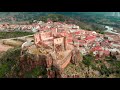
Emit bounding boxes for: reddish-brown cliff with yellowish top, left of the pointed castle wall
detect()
[20,46,71,78]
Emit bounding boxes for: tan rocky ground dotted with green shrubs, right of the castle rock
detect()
[62,58,120,78]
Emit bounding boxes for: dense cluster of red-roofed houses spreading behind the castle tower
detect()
[34,21,120,57]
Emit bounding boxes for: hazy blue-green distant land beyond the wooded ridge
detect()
[0,12,120,29]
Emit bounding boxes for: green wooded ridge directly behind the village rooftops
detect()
[30,14,103,32]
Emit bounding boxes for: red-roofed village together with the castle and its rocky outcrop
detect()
[15,20,120,78]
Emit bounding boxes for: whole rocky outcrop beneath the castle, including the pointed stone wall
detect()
[20,42,85,78]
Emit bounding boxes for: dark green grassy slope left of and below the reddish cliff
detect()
[0,47,45,78]
